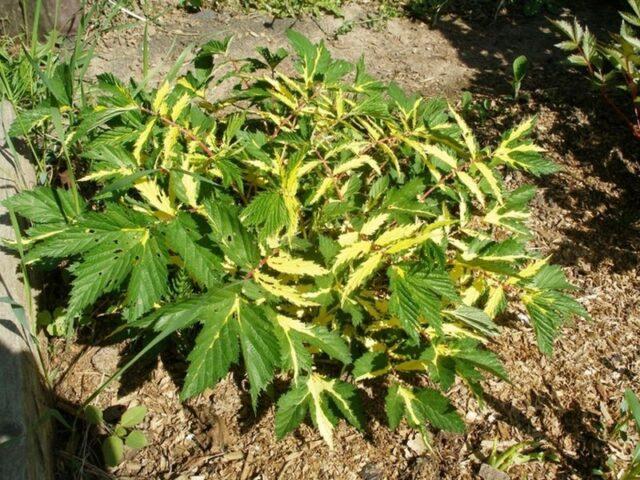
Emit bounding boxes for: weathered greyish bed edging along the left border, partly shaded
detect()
[0,102,52,480]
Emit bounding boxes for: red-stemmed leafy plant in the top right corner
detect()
[553,0,640,139]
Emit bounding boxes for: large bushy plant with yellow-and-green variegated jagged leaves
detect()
[6,31,586,445]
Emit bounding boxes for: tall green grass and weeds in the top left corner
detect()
[0,0,146,187]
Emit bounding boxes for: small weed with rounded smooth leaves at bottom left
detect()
[84,405,148,467]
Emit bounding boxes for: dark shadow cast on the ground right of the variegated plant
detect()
[412,1,640,272]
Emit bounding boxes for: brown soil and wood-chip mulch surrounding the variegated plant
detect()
[50,2,640,480]
